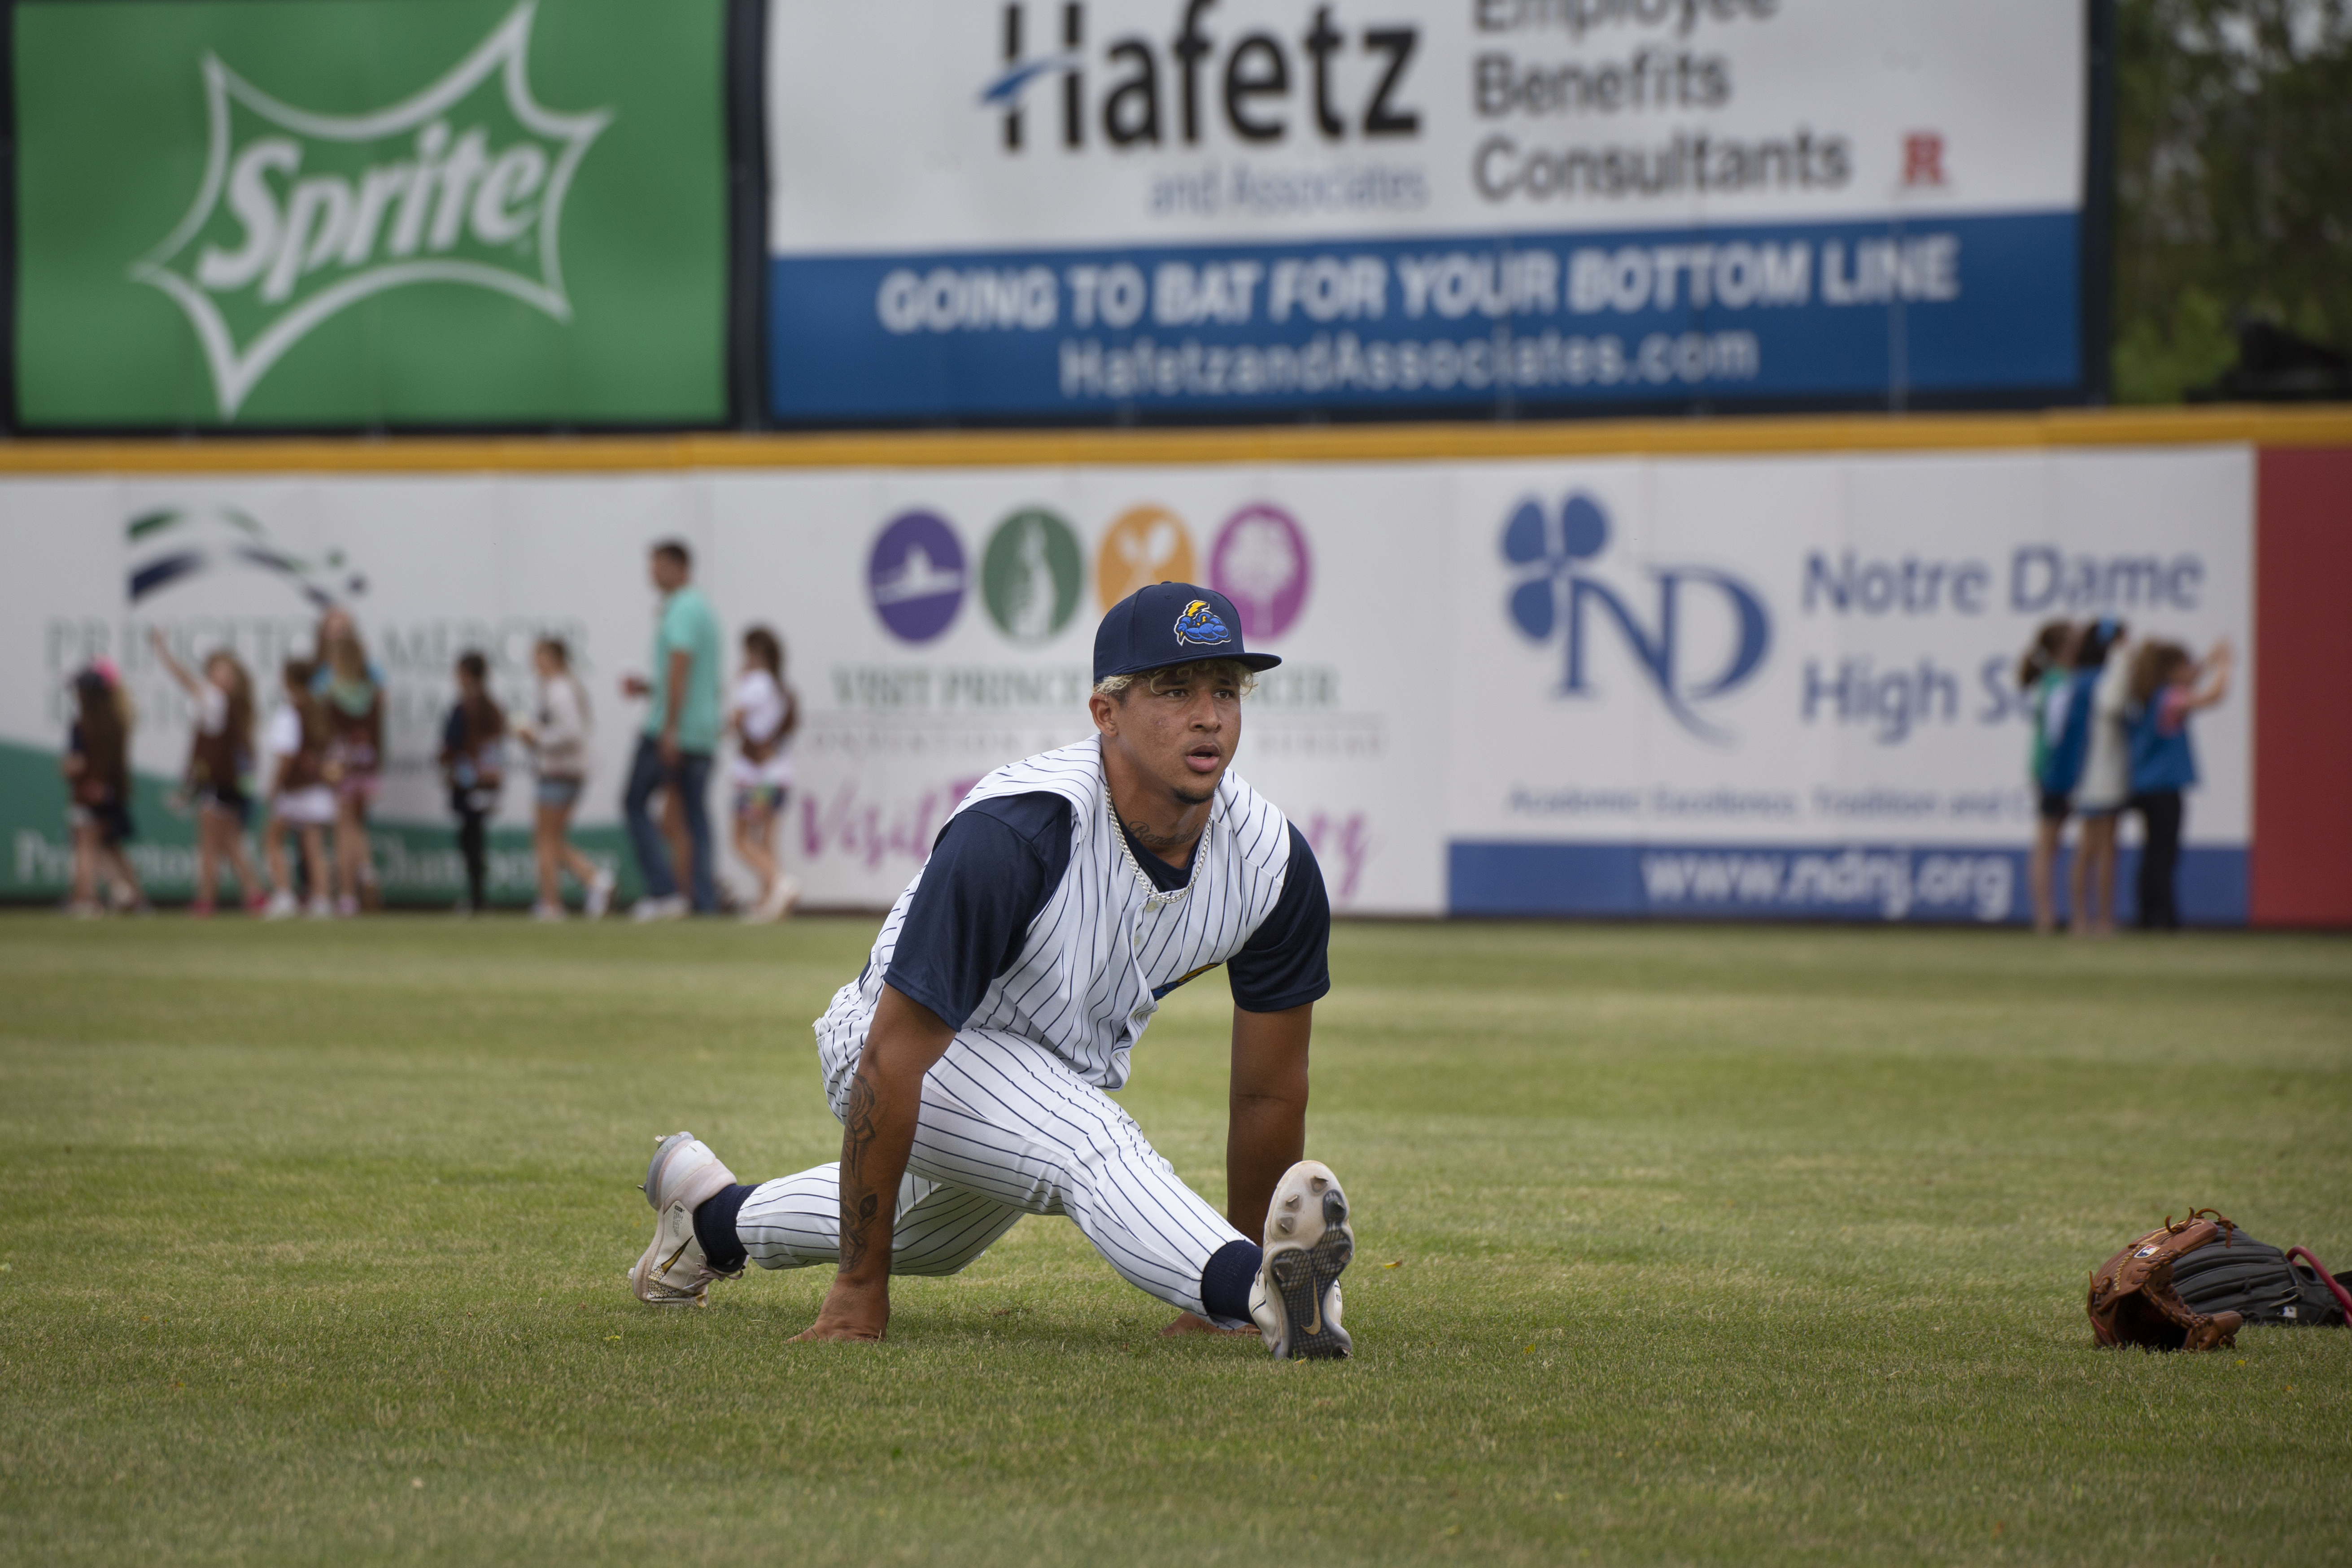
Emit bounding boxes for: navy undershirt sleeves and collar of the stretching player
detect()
[884,792,1331,1030]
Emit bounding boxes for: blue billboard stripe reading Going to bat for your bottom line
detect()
[769,212,2081,421]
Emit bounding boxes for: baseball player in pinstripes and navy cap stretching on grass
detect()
[630,583,1355,1359]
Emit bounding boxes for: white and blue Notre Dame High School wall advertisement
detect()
[1446,449,2256,922]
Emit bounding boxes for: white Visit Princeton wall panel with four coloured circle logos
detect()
[706,468,1446,912]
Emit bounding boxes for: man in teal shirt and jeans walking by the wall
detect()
[621,538,722,919]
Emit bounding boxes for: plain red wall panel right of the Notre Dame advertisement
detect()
[2248,447,2352,926]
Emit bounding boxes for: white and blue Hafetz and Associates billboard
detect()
[767,0,2086,421]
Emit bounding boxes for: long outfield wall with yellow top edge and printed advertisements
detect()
[0,414,2352,924]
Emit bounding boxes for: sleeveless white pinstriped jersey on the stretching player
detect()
[816,738,1291,1098]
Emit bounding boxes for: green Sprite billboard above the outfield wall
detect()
[12,0,727,428]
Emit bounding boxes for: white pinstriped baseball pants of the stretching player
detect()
[736,1030,1244,1312]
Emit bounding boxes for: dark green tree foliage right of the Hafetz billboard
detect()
[2114,0,2352,402]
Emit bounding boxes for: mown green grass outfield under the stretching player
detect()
[0,915,2352,1568]
